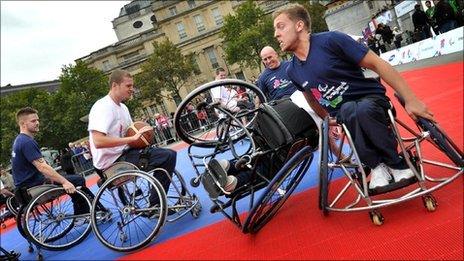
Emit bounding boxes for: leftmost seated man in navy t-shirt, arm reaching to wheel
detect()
[11,107,104,214]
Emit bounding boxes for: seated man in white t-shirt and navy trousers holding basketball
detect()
[88,70,177,204]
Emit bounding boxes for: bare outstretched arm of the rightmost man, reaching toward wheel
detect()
[359,50,435,121]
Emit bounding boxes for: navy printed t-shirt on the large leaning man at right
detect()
[287,31,385,116]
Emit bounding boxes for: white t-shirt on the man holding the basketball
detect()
[88,95,132,170]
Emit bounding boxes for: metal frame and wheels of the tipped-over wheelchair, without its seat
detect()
[174,79,313,233]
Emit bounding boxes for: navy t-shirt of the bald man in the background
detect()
[256,61,296,100]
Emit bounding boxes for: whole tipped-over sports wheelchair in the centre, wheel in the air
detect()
[174,79,319,233]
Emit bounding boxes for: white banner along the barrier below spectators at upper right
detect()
[380,27,464,65]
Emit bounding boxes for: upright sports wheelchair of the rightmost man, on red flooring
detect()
[319,94,464,223]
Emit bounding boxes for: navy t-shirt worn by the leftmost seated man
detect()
[11,133,45,187]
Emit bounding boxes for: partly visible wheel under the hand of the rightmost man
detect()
[418,118,464,167]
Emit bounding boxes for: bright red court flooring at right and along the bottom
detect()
[120,62,464,260]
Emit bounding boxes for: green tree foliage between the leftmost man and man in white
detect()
[0,62,109,164]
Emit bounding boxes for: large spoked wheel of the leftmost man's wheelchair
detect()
[24,187,91,250]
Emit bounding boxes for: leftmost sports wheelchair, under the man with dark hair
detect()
[10,184,92,260]
